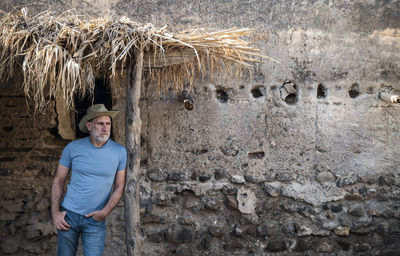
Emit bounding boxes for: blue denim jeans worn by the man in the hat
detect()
[57,209,106,256]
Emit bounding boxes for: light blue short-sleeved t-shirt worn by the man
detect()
[60,137,126,215]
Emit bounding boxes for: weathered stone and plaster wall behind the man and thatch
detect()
[0,0,400,255]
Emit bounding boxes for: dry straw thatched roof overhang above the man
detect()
[0,9,276,110]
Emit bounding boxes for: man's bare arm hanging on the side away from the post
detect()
[51,163,71,230]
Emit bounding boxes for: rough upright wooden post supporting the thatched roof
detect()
[125,49,143,256]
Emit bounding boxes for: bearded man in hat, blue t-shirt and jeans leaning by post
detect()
[51,104,126,256]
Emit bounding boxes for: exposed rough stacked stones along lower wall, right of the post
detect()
[141,165,400,255]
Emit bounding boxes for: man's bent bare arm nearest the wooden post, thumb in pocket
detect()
[85,169,125,221]
